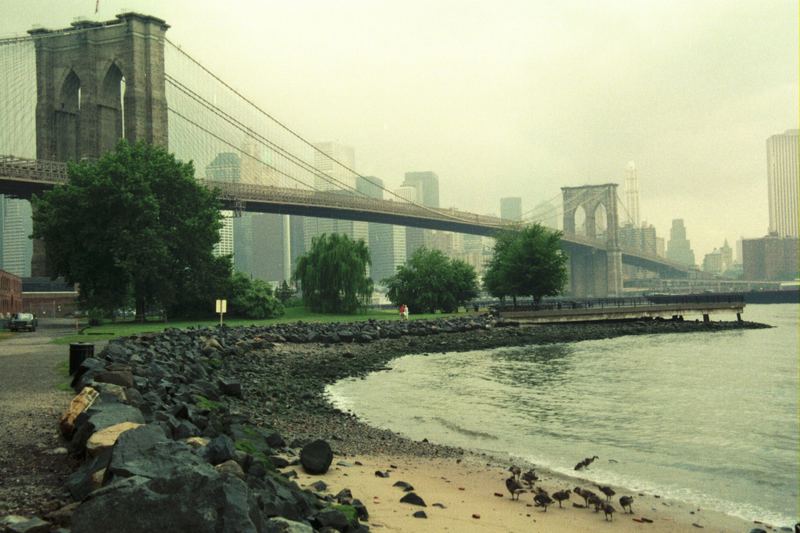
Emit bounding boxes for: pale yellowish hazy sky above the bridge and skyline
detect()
[0,0,800,263]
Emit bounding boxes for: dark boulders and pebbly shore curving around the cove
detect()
[7,315,768,533]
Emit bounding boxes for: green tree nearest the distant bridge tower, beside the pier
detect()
[483,224,567,302]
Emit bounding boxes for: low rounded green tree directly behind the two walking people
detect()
[383,248,478,313]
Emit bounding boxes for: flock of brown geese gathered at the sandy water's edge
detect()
[506,456,633,520]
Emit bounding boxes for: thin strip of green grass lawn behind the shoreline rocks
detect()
[53,307,463,344]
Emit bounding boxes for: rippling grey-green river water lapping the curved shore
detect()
[328,304,800,525]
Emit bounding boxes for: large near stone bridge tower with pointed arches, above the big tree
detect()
[28,13,169,161]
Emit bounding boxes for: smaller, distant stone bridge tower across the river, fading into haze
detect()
[561,183,622,297]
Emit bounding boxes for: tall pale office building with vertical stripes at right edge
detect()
[767,130,800,237]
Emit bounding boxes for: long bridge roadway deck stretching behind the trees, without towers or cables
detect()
[0,155,687,277]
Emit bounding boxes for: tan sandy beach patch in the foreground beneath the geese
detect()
[296,455,764,533]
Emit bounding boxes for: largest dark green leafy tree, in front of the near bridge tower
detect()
[33,141,225,320]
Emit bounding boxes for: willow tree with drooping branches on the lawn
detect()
[292,233,372,313]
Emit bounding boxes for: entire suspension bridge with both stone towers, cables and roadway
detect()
[0,13,688,297]
